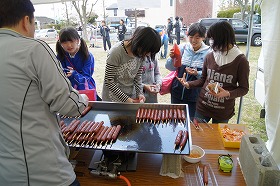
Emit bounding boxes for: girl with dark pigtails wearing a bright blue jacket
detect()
[56,27,98,100]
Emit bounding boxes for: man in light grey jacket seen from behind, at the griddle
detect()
[0,0,88,186]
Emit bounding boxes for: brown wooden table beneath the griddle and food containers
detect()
[72,124,246,186]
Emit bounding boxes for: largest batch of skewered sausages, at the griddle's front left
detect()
[60,119,121,148]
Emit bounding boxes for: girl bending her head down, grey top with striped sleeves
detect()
[102,27,161,103]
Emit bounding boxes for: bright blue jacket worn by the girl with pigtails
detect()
[59,51,96,90]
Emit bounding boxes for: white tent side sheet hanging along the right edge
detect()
[261,0,280,168]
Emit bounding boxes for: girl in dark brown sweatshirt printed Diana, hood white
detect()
[178,21,250,123]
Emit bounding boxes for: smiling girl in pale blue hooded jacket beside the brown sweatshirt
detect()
[165,23,210,120]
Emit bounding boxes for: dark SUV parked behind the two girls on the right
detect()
[198,18,262,46]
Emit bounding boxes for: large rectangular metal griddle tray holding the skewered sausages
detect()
[63,101,191,155]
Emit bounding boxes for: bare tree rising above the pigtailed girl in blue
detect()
[72,0,98,41]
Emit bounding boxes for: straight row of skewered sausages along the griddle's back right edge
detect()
[136,108,186,124]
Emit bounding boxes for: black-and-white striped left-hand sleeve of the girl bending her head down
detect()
[104,63,129,102]
